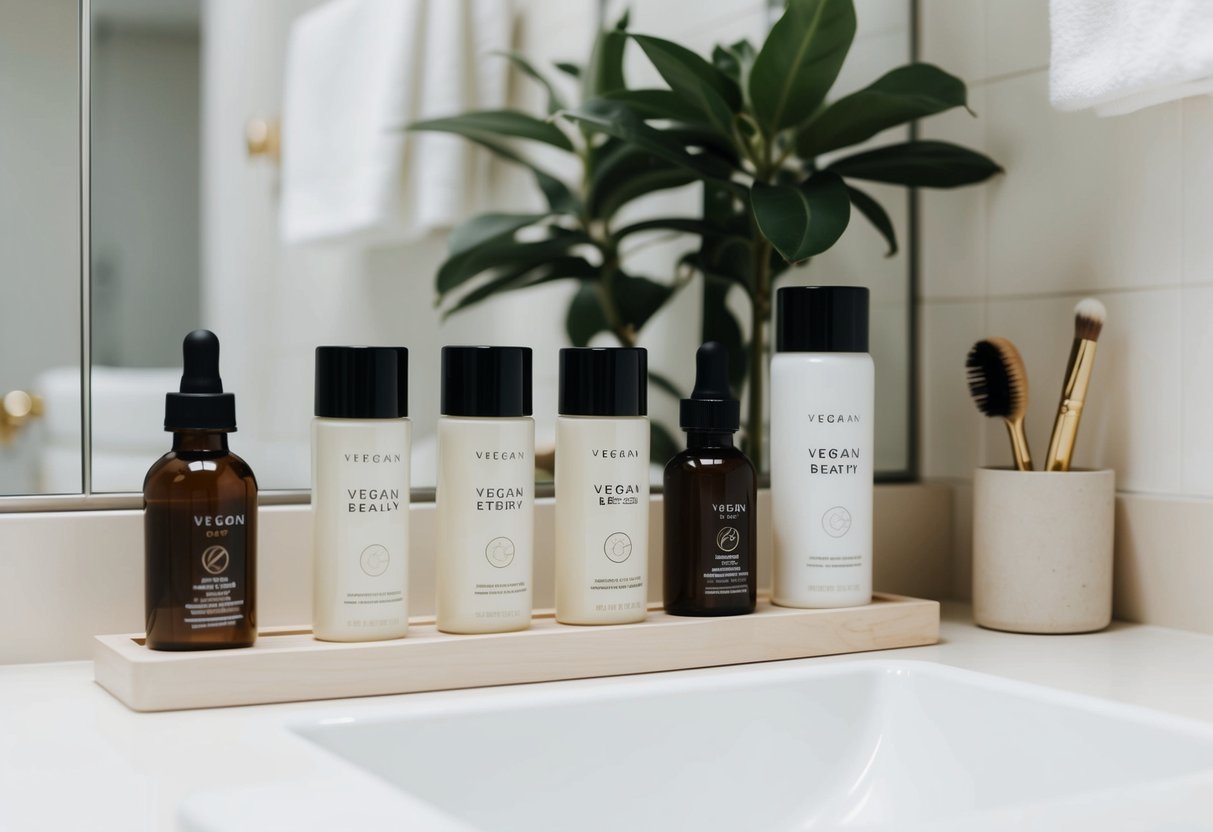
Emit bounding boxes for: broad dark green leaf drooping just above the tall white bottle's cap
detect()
[752,173,850,262]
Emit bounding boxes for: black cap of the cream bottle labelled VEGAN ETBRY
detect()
[442,347,531,417]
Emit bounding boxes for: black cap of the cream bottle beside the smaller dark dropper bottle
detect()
[557,347,649,416]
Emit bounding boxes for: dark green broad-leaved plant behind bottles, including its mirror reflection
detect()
[411,0,1001,461]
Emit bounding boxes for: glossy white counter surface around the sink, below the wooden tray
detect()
[0,604,1213,832]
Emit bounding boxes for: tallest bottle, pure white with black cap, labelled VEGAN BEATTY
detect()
[770,286,876,608]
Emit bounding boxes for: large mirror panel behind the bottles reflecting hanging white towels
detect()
[75,0,910,491]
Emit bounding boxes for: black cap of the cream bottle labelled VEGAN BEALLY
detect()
[315,347,409,418]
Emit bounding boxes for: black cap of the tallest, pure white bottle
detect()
[775,286,867,353]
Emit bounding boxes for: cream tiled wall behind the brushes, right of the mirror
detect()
[919,0,1213,626]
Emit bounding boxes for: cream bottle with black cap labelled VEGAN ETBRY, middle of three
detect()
[435,347,535,633]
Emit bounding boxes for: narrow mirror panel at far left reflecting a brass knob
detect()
[0,0,82,494]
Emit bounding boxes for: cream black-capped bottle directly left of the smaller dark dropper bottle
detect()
[556,348,649,625]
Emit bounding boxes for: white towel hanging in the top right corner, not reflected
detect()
[1049,0,1213,115]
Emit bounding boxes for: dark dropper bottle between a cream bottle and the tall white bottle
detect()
[662,341,758,615]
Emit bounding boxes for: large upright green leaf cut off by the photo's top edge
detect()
[747,0,855,136]
